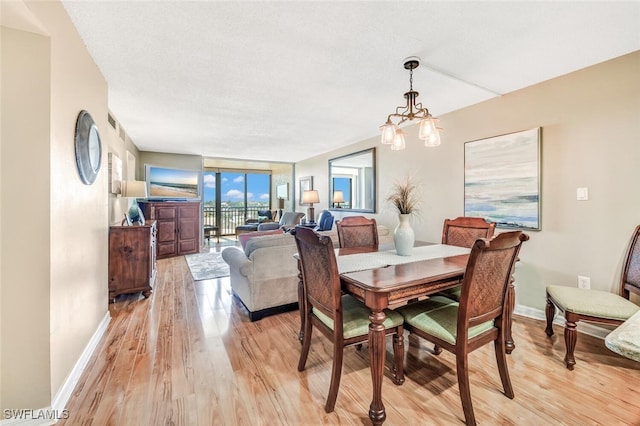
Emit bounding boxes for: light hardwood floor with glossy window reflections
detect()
[58,250,640,426]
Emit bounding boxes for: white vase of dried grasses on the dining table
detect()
[387,176,420,256]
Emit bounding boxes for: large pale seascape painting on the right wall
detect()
[464,127,541,231]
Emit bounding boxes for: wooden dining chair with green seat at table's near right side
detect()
[397,231,529,425]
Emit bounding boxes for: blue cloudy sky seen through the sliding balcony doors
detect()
[204,172,269,203]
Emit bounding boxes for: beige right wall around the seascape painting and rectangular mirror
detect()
[296,52,640,309]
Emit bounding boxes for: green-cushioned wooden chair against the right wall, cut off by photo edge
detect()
[545,225,640,370]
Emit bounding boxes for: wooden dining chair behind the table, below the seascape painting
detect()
[440,217,496,301]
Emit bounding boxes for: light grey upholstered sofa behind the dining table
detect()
[222,225,393,321]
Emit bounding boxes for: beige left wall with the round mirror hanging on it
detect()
[0,1,109,409]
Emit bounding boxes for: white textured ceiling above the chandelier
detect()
[58,0,640,162]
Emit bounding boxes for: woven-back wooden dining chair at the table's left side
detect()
[295,226,404,413]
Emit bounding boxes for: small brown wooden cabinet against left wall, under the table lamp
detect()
[109,220,156,301]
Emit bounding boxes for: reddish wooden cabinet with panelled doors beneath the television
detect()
[138,201,200,259]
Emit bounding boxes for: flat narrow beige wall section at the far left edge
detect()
[0,27,51,409]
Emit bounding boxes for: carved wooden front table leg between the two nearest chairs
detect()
[369,310,387,425]
